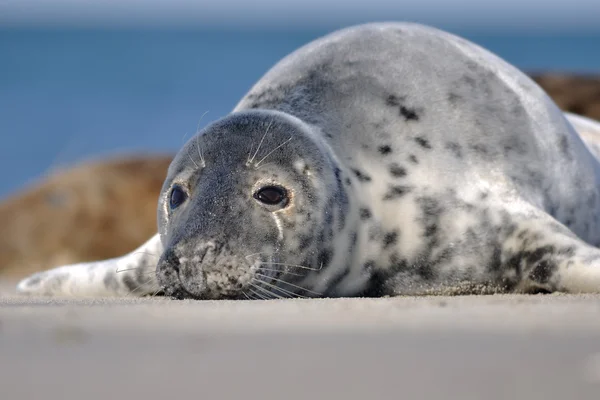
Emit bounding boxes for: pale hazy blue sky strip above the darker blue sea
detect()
[0,0,600,32]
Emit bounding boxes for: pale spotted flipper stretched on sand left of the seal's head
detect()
[17,234,162,297]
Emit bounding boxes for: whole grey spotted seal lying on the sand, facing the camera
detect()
[18,23,600,299]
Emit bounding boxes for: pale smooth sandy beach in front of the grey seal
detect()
[0,284,600,400]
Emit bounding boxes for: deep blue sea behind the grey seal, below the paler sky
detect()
[0,29,600,196]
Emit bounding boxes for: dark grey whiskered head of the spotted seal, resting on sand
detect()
[156,110,348,299]
